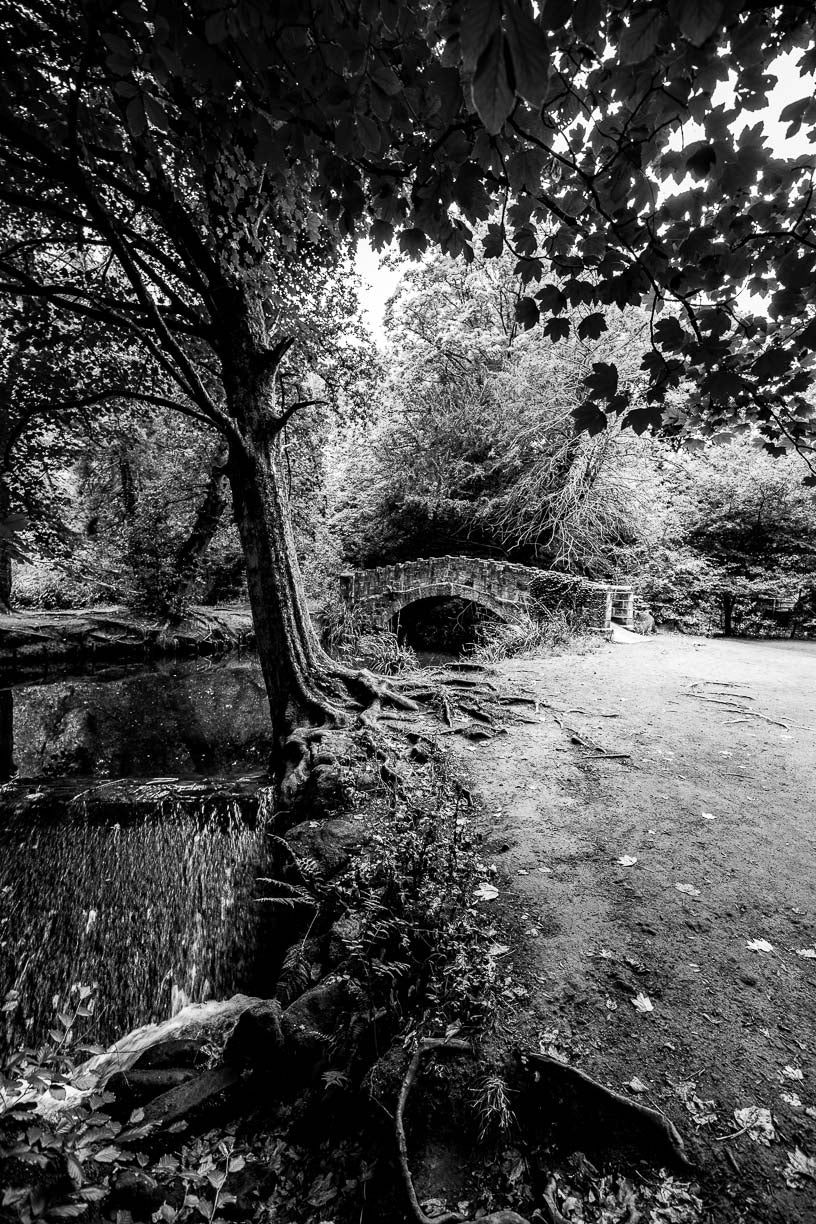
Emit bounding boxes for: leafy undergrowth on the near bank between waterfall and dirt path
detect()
[0,731,504,1224]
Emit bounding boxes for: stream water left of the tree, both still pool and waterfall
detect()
[0,656,274,1048]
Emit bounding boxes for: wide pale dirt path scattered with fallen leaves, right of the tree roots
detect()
[464,636,816,1224]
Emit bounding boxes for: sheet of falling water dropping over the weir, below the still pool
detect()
[0,803,278,1043]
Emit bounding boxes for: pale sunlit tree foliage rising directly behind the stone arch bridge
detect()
[333,248,685,577]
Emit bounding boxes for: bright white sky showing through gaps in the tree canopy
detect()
[356,51,816,339]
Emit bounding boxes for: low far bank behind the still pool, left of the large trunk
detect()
[0,606,254,674]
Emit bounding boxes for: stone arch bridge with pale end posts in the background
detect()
[340,557,634,629]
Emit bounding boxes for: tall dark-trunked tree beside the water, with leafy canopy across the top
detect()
[0,0,816,733]
